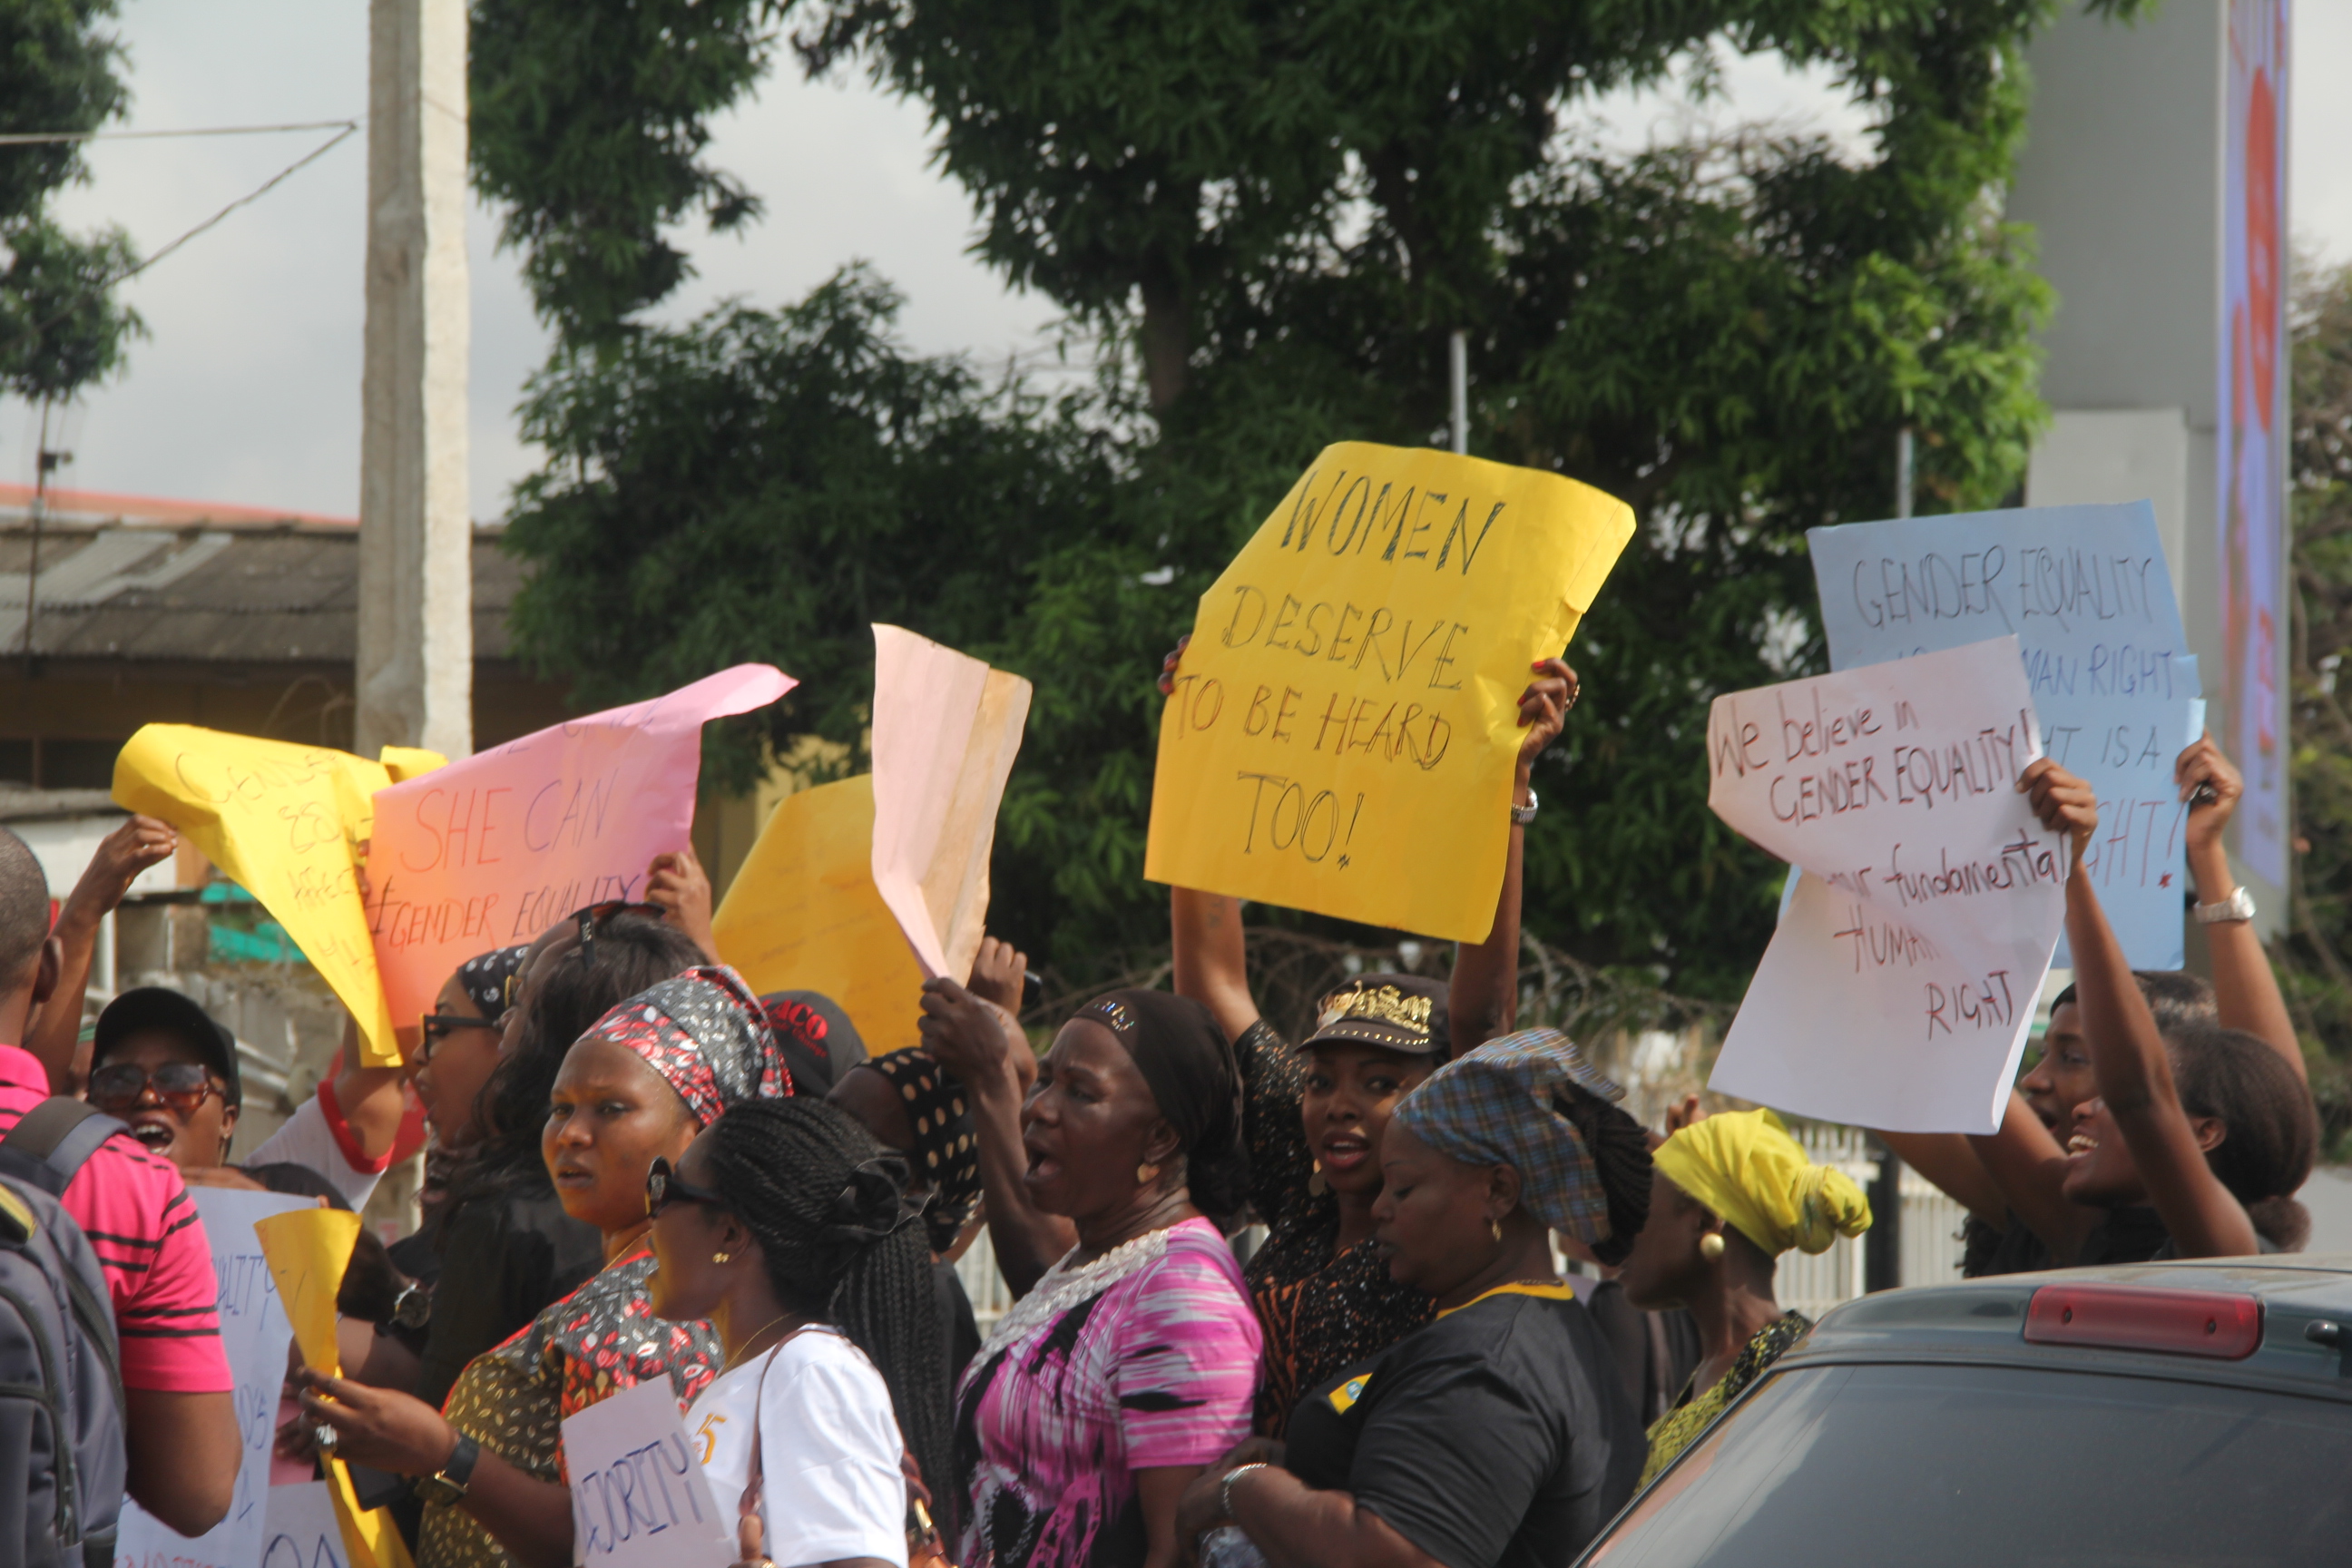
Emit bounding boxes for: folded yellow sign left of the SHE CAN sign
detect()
[115,724,440,1067]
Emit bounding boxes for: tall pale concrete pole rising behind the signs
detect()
[353,0,473,757]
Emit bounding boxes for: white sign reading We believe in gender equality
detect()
[1708,637,2067,1133]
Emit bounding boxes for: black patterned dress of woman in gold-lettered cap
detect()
[1232,1018,1437,1436]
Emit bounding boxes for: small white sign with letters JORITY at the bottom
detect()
[564,1377,736,1568]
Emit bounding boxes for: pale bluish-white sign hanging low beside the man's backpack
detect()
[115,1187,325,1568]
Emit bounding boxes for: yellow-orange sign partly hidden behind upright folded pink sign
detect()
[710,773,931,1055]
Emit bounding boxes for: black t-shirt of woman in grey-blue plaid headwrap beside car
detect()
[1284,1286,1646,1568]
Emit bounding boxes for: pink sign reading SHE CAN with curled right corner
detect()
[367,665,798,1023]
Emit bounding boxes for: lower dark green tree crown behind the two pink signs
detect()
[508,268,1108,766]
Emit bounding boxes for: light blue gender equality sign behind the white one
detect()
[1807,501,2204,968]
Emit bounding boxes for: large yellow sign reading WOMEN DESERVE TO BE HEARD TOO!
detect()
[1143,442,1632,943]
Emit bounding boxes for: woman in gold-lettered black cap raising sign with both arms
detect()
[1160,644,1576,1436]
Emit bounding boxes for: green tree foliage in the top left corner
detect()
[0,0,139,402]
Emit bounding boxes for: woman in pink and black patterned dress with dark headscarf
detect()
[955,990,1259,1568]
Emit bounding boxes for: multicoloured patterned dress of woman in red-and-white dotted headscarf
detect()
[416,1250,724,1568]
